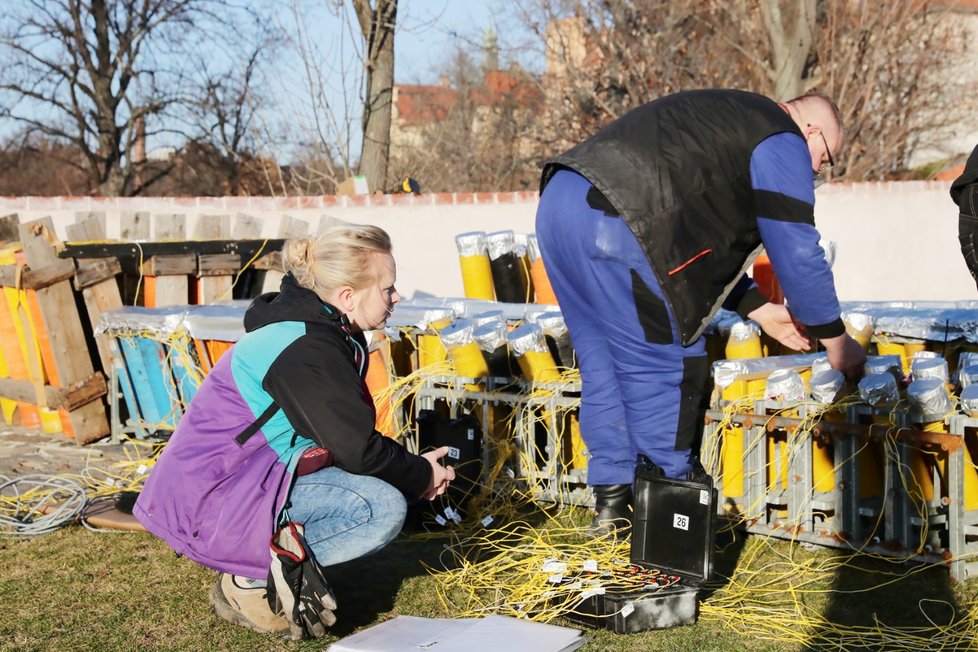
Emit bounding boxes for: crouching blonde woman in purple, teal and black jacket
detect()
[133,225,455,634]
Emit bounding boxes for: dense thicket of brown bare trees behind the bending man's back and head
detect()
[524,0,966,180]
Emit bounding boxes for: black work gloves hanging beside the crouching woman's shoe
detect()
[268,521,336,641]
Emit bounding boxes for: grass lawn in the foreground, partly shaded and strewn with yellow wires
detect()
[0,510,978,652]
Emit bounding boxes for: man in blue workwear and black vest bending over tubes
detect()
[536,90,865,533]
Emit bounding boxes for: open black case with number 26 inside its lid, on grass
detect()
[568,466,717,634]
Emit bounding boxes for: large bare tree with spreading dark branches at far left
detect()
[0,0,266,195]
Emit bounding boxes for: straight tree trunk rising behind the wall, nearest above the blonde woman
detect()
[353,0,397,192]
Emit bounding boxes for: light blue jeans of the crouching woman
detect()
[288,466,407,566]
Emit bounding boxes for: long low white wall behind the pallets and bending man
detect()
[0,182,978,301]
